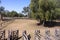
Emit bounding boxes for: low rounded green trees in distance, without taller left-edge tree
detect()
[2,11,24,17]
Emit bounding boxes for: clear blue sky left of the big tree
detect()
[1,0,30,12]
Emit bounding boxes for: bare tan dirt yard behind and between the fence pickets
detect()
[2,19,60,40]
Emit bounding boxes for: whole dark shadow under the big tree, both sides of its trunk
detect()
[37,21,60,27]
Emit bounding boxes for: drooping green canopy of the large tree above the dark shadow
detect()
[30,0,56,21]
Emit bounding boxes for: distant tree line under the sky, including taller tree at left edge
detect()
[0,6,26,17]
